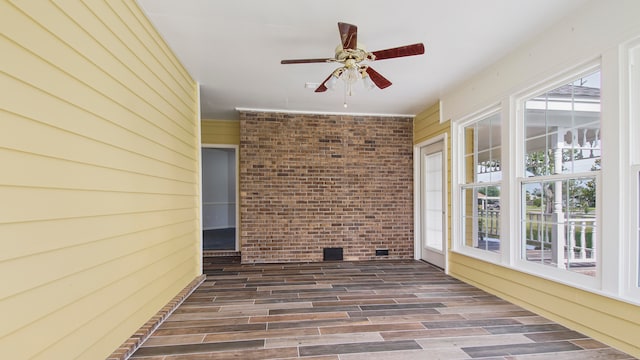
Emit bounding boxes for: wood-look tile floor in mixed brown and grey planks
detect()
[131,259,634,360]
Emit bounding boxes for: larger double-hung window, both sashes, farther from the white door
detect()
[519,70,601,276]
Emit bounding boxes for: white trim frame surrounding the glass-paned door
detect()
[413,133,451,274]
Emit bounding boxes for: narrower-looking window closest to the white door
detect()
[460,113,502,253]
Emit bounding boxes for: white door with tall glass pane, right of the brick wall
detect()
[420,141,447,269]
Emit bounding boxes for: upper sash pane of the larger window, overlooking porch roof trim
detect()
[524,71,601,177]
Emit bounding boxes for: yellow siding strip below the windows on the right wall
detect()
[449,253,640,357]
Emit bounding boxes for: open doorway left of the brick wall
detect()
[202,145,239,251]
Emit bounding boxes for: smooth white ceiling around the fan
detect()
[137,0,587,119]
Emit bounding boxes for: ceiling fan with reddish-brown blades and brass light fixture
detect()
[280,22,424,95]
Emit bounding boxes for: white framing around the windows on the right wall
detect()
[444,42,640,305]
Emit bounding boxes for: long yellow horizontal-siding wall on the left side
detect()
[0,0,201,359]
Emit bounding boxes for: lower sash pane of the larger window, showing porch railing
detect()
[521,177,597,276]
